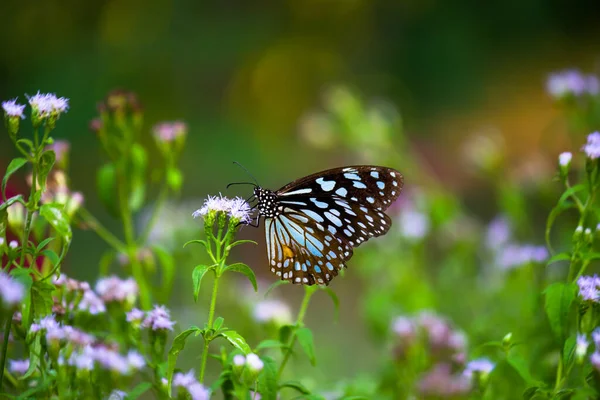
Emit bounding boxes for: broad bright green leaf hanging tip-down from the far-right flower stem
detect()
[544,282,576,342]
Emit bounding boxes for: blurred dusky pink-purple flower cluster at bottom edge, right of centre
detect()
[417,363,471,397]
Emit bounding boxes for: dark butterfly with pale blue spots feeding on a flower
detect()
[244,165,404,285]
